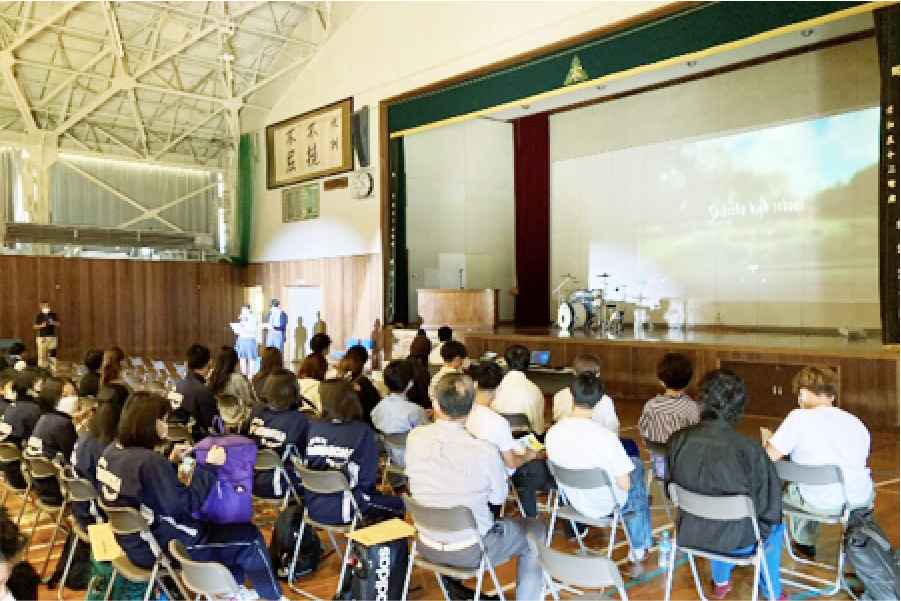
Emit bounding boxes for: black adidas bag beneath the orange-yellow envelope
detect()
[335,538,410,601]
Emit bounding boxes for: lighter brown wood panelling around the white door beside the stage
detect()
[243,255,383,349]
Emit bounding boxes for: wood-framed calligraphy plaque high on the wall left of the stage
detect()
[266,98,354,190]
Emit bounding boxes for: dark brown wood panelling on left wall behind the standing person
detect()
[0,255,245,361]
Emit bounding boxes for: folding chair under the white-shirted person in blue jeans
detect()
[545,461,631,558]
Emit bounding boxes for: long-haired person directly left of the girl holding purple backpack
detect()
[69,384,129,528]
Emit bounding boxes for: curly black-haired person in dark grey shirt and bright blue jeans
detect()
[666,369,788,599]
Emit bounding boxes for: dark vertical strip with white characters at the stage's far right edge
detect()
[873,5,901,344]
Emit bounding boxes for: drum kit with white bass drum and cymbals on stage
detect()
[554,273,625,335]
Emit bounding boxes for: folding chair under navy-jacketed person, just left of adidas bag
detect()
[288,461,363,599]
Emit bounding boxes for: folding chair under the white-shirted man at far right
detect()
[775,461,851,597]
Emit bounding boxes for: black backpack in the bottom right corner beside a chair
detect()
[843,507,899,599]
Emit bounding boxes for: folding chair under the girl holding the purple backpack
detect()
[100,502,188,601]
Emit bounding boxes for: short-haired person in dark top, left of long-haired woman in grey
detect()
[169,344,219,440]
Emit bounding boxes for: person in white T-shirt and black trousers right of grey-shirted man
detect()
[466,361,555,518]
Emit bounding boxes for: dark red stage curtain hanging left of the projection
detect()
[502,115,551,326]
